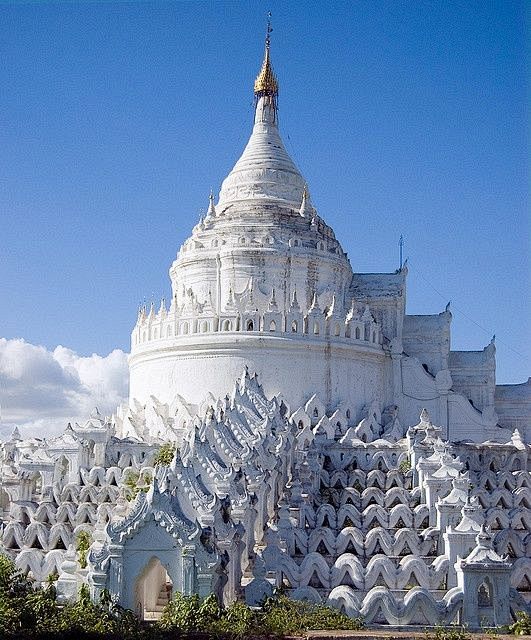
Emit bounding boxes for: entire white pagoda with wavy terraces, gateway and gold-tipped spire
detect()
[0,30,531,626]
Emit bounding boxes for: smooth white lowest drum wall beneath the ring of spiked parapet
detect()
[130,333,391,418]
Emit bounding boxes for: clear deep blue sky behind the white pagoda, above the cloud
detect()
[0,0,531,382]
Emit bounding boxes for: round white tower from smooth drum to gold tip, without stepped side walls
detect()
[129,33,384,418]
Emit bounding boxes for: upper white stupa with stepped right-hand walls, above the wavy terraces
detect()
[124,28,521,441]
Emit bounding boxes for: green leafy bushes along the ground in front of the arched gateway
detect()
[0,555,366,640]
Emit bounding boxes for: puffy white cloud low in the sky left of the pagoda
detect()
[0,338,129,438]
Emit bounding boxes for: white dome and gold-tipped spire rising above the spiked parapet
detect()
[170,34,352,314]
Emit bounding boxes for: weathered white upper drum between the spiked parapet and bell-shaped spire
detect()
[170,216,352,311]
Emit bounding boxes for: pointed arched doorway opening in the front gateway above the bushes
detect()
[135,557,173,620]
